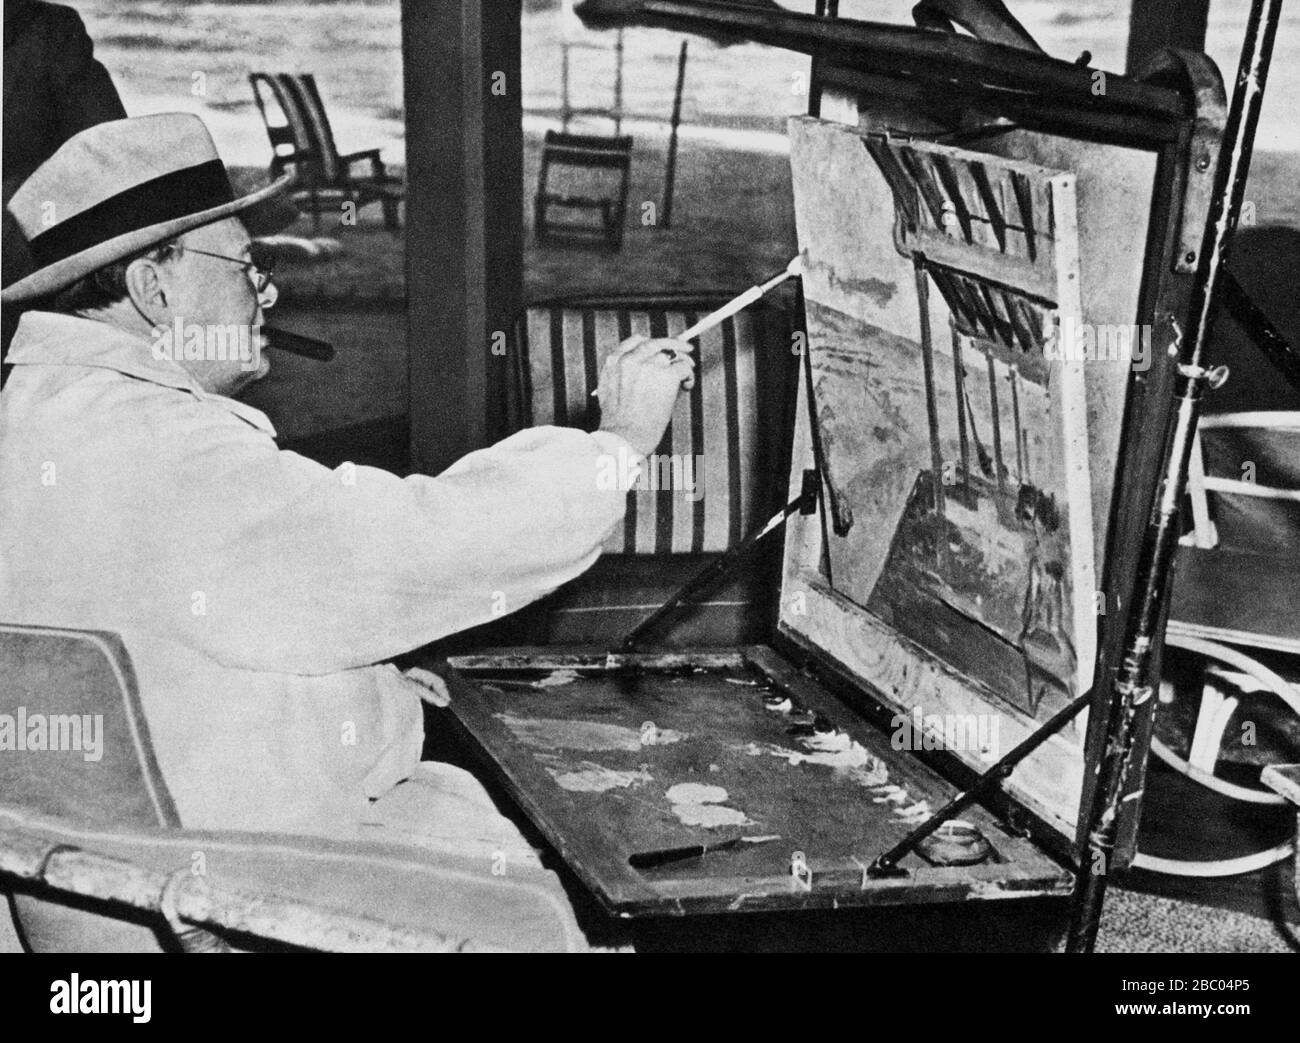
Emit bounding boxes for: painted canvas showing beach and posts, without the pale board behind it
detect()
[793,121,1096,713]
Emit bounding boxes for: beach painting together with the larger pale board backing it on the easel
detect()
[781,114,1164,831]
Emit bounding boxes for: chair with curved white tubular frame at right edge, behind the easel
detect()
[1136,412,1300,875]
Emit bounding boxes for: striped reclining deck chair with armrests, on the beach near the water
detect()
[248,73,406,231]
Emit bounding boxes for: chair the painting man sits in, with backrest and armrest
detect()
[0,623,586,952]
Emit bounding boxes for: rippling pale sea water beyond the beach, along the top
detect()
[72,0,1300,165]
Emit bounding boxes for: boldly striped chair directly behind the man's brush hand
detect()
[508,295,798,644]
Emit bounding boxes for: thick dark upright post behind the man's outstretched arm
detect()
[402,0,524,475]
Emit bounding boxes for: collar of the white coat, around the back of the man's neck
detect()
[5,311,276,438]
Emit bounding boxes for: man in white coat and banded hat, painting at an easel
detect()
[0,114,693,941]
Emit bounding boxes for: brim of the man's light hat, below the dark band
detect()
[0,174,299,304]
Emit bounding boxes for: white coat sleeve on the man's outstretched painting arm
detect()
[147,421,640,674]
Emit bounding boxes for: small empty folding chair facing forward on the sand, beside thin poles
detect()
[534,130,632,251]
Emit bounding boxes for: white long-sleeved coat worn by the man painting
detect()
[0,312,631,836]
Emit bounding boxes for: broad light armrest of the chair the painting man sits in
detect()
[0,806,586,952]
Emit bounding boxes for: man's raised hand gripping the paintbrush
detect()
[597,337,696,456]
